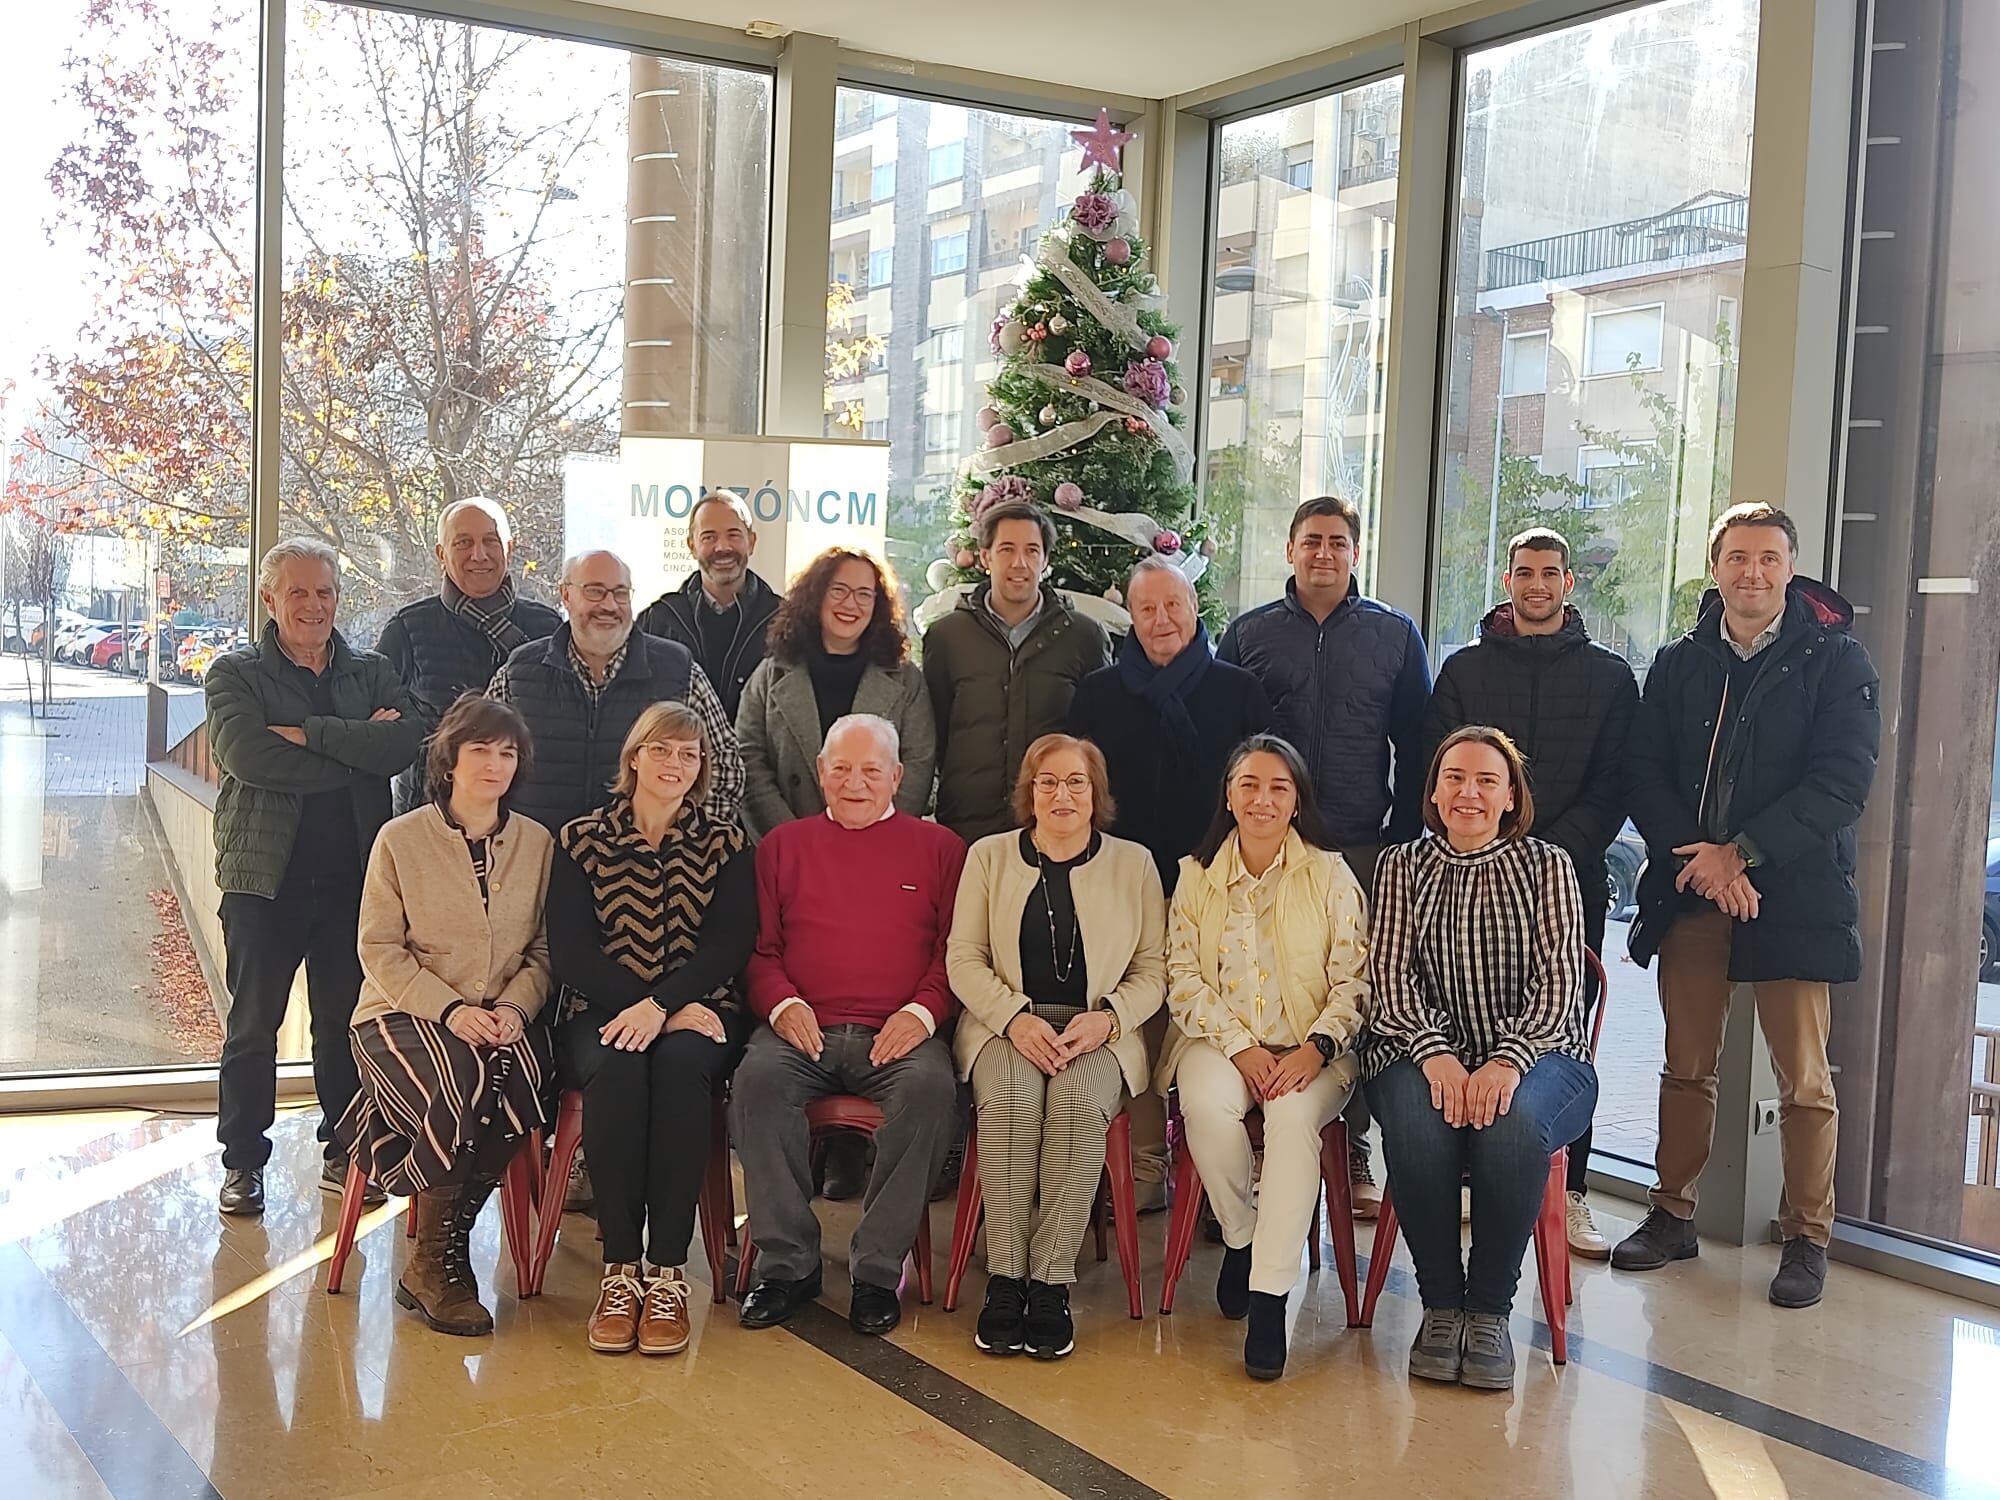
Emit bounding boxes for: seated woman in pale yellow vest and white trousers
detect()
[1154,734,1368,1380]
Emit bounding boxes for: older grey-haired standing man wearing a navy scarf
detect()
[1070,558,1270,1212]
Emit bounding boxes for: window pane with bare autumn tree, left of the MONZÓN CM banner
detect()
[280,0,772,642]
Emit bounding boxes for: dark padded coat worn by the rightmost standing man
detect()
[1628,578,1882,984]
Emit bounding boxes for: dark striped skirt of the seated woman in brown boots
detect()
[336,1010,552,1196]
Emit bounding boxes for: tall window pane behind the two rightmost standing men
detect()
[1430,0,1758,1162]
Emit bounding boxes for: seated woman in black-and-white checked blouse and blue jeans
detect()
[1362,724,1598,1390]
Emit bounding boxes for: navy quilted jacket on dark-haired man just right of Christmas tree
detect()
[1218,582,1430,848]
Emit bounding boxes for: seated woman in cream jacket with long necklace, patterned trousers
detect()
[944,734,1166,1360]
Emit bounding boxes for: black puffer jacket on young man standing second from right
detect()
[1422,604,1638,912]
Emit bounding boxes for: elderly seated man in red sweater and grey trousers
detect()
[730,714,966,1334]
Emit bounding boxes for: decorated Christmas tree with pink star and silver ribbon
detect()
[918,110,1222,630]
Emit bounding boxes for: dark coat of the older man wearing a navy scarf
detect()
[1070,662,1270,896]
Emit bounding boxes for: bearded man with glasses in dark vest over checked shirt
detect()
[488,552,744,832]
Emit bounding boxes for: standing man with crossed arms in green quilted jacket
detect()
[202,538,424,1214]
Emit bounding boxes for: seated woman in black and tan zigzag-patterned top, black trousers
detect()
[548,702,756,1354]
